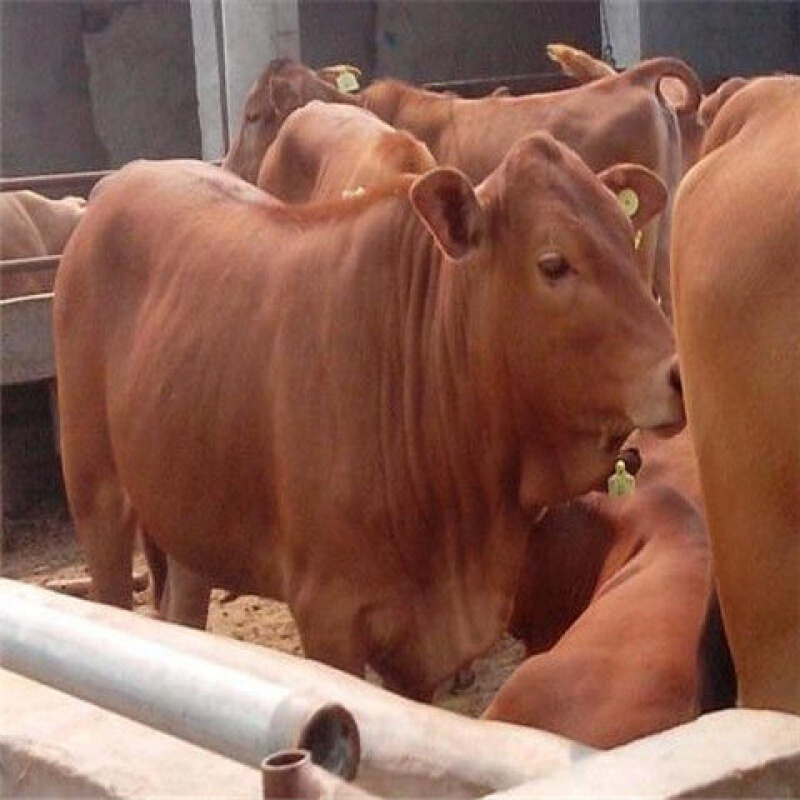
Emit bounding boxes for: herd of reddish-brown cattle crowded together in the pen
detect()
[2,46,800,747]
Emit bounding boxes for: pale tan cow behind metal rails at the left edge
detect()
[0,190,86,297]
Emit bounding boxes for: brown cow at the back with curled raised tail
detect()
[359,58,702,316]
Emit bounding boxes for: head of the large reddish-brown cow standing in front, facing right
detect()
[411,134,683,506]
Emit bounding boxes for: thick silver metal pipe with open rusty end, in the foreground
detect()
[0,579,360,779]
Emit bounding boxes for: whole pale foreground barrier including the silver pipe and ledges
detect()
[0,579,800,800]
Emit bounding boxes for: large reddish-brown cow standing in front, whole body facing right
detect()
[54,135,683,697]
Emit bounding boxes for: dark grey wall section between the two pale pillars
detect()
[300,0,600,82]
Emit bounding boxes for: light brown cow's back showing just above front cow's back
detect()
[257,100,436,203]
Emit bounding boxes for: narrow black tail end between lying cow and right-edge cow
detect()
[697,589,738,714]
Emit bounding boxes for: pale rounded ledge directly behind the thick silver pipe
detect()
[0,581,592,797]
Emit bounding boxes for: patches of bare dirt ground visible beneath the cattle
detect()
[0,499,523,716]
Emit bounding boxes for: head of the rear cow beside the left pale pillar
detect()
[222,58,358,183]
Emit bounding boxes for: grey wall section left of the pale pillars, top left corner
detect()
[0,0,200,176]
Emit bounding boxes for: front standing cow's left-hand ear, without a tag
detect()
[410,167,485,260]
